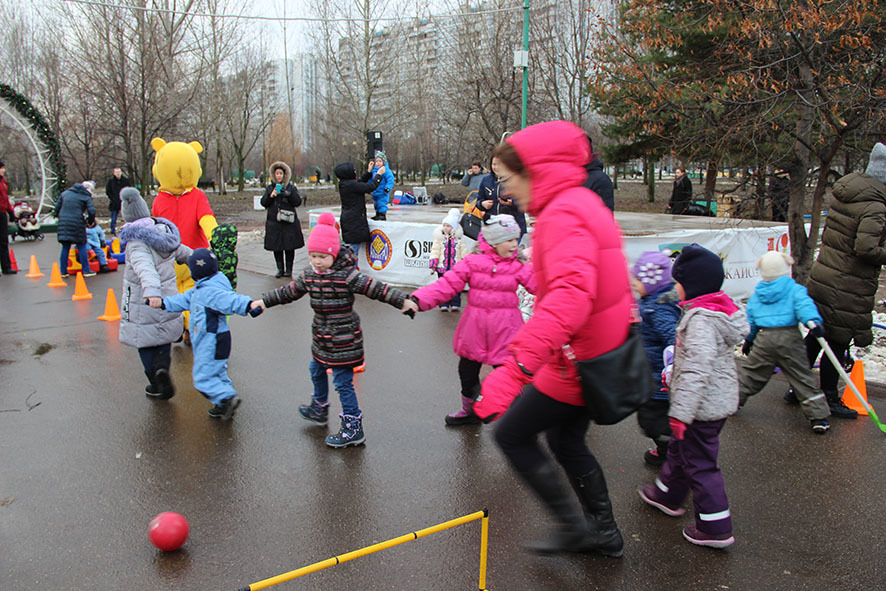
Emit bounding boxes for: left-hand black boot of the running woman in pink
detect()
[520,463,591,554]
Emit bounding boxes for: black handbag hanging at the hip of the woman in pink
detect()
[566,323,653,425]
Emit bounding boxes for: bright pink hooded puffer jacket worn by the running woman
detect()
[506,121,633,406]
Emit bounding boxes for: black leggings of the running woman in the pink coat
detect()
[495,386,600,476]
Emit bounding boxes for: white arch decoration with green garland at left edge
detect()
[0,84,66,216]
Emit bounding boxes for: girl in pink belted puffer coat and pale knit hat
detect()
[412,215,535,426]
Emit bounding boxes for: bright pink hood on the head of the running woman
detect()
[505,121,591,215]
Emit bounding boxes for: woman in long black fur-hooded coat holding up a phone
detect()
[261,162,305,277]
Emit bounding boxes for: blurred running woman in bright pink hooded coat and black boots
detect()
[473,121,633,556]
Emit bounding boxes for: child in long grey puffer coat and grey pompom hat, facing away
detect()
[120,187,192,400]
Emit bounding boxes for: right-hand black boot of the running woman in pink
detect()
[569,470,624,557]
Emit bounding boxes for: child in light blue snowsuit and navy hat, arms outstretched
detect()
[156,248,262,420]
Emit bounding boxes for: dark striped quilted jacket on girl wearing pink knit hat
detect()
[262,244,407,368]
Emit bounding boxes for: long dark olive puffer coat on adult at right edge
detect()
[806,172,886,347]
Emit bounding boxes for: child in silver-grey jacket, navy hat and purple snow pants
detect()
[640,244,749,548]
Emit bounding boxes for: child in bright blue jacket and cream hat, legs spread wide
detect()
[739,251,831,434]
